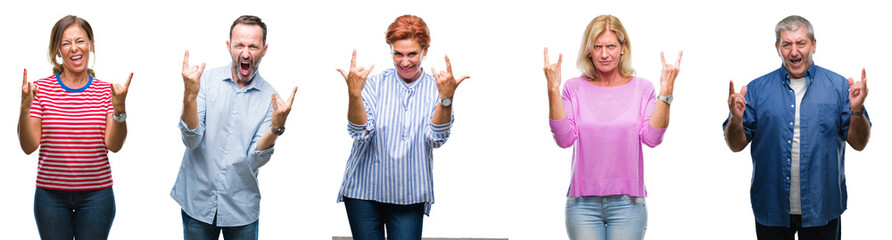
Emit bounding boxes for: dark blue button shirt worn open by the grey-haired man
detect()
[722,64,870,227]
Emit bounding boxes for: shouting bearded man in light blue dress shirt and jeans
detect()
[170,15,297,240]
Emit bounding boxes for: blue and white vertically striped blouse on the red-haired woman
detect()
[338,68,455,215]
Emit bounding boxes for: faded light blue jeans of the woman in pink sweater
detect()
[566,195,647,239]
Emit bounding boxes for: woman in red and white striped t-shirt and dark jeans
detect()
[18,15,133,240]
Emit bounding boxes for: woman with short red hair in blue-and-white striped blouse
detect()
[338,15,468,239]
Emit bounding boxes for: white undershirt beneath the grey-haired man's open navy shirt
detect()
[788,78,808,214]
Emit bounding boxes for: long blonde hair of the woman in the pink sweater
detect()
[576,15,635,80]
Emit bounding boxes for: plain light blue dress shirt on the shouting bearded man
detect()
[170,65,278,227]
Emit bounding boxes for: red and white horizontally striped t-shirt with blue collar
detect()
[31,75,114,191]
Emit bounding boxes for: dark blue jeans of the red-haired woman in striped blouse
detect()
[344,197,424,240]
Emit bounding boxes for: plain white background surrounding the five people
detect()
[0,1,892,239]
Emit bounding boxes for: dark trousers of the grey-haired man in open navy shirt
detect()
[756,215,842,240]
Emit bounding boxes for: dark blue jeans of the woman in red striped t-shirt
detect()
[34,187,115,240]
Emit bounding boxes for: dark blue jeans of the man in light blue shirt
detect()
[180,209,260,240]
